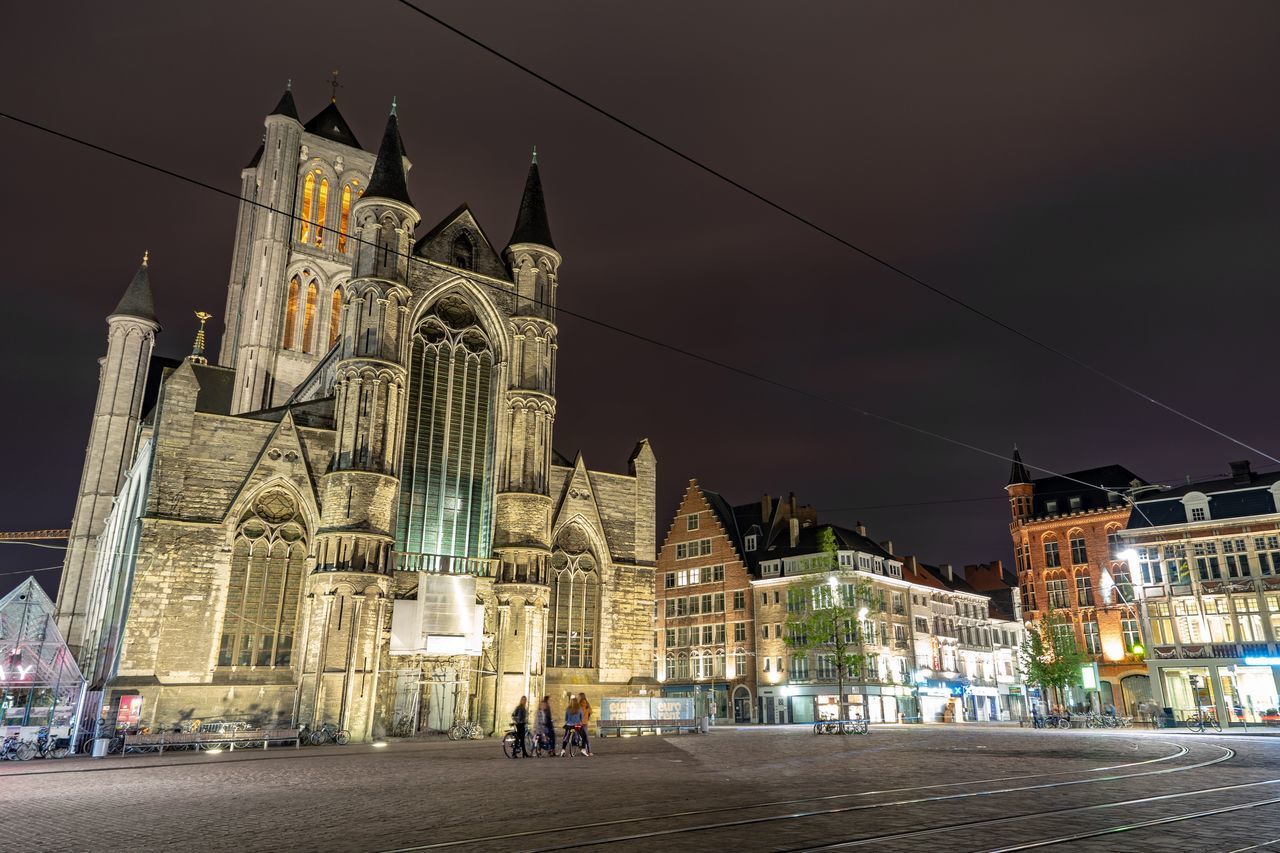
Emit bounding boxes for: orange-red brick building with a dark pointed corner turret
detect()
[1005,447,1149,715]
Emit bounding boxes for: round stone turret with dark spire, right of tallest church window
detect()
[493,150,561,710]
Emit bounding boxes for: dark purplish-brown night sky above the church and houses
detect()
[0,0,1280,590]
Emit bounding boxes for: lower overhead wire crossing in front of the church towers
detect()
[0,111,1208,502]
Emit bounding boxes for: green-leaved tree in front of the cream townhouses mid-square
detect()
[786,528,872,720]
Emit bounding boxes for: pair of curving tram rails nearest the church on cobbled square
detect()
[384,742,1208,853]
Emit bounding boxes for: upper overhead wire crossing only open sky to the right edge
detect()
[394,0,1280,464]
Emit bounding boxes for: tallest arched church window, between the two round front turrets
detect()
[396,296,494,557]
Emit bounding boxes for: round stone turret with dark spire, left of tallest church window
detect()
[301,101,419,739]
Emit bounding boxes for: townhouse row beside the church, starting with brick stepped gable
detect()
[654,480,1024,724]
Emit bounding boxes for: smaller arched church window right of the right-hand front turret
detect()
[547,525,600,669]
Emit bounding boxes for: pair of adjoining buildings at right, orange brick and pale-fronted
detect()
[1006,448,1280,725]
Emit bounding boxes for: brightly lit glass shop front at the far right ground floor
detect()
[1151,657,1280,726]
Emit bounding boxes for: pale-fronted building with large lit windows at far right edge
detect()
[1120,461,1280,725]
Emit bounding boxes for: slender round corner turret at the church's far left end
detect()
[58,255,160,658]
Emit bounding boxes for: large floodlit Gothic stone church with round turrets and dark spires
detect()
[58,91,655,738]
